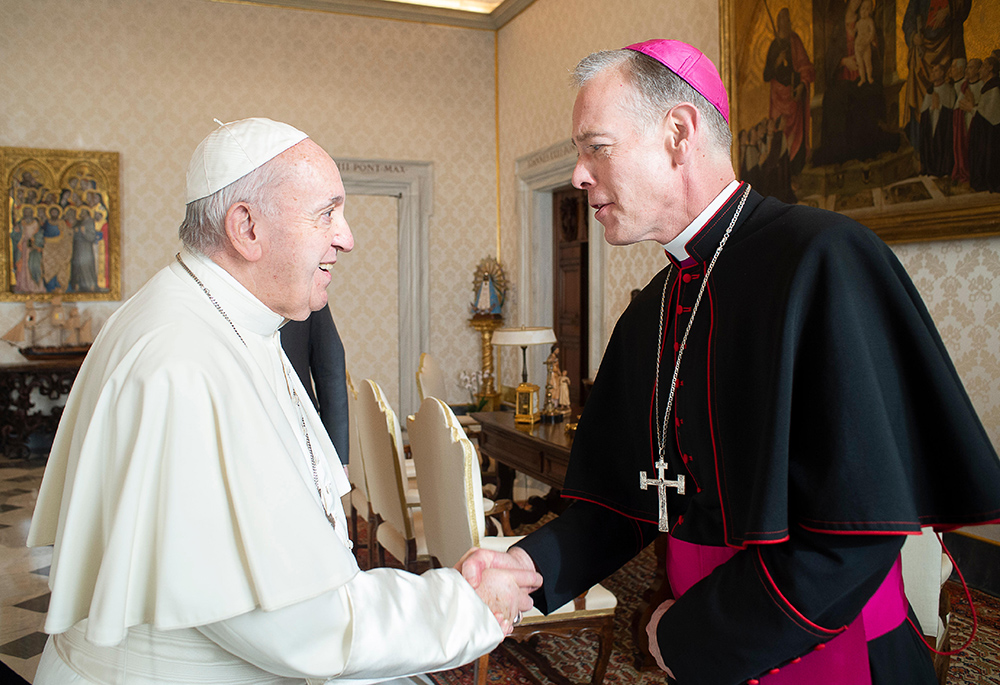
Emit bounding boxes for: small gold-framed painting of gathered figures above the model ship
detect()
[0,147,121,302]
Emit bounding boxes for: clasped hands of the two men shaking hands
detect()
[455,547,542,635]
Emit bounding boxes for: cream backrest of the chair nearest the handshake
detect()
[407,397,486,566]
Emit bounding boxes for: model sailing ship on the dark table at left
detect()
[2,297,94,361]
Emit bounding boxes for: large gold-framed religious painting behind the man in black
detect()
[719,0,1000,241]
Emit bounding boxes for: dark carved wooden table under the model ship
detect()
[0,357,83,459]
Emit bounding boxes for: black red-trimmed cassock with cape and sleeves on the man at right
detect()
[518,187,1000,685]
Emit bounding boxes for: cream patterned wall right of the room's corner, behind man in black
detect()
[499,0,1000,454]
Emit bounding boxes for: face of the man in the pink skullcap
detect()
[573,68,684,245]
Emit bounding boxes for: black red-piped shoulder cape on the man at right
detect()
[563,186,1000,547]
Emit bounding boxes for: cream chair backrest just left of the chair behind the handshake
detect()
[358,378,414,539]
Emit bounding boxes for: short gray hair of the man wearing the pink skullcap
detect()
[573,50,733,157]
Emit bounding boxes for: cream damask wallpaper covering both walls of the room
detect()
[0,0,1000,454]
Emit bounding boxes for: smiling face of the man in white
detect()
[254,139,354,321]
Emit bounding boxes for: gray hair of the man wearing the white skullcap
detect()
[177,157,285,257]
